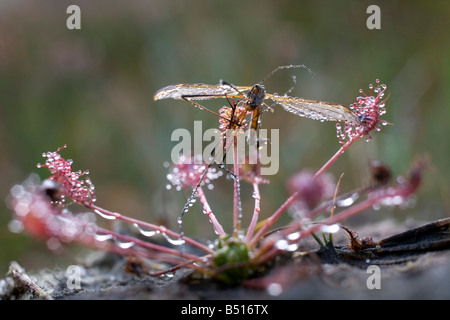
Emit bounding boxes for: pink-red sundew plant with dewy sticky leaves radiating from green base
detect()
[9,80,424,285]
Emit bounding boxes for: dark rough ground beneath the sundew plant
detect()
[0,219,450,300]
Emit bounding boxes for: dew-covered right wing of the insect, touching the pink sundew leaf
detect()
[266,94,360,125]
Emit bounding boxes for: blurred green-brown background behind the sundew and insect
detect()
[0,0,450,275]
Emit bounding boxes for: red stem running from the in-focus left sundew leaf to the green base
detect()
[84,202,213,254]
